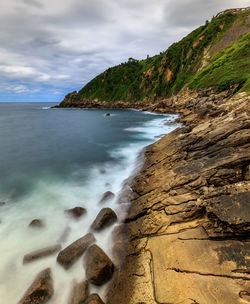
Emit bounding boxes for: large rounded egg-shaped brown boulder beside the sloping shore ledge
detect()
[84,245,114,286]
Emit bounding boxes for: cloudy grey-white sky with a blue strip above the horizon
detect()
[0,0,249,102]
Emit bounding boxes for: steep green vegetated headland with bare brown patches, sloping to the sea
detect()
[57,8,250,107]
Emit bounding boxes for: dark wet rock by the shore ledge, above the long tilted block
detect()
[91,208,117,231]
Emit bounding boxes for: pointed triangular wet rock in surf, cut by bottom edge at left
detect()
[18,268,54,304]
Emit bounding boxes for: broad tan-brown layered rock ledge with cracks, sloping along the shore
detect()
[107,91,250,304]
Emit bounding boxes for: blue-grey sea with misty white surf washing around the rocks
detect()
[0,103,177,304]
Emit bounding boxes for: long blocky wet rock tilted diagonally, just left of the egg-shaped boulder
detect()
[57,233,95,269]
